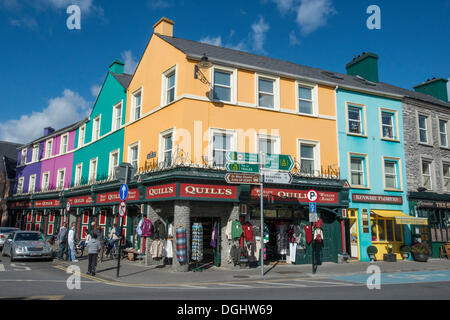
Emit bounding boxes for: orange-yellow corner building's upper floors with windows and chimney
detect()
[124,18,338,175]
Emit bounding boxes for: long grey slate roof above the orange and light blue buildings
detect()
[156,34,450,108]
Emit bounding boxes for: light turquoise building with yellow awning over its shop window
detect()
[336,89,411,261]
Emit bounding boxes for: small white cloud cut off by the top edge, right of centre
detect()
[297,0,337,35]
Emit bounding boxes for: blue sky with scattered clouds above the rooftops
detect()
[0,0,450,142]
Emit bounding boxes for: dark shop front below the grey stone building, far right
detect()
[408,192,450,258]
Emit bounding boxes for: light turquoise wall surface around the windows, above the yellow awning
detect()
[337,89,410,261]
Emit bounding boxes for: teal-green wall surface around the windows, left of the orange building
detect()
[71,67,127,186]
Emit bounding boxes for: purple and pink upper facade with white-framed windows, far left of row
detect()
[14,122,78,194]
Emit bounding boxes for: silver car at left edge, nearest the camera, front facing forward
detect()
[2,231,53,262]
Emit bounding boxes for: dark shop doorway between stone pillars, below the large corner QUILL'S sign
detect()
[191,217,220,268]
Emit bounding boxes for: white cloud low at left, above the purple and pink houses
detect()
[0,89,90,143]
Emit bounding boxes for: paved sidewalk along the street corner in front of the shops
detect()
[54,257,450,286]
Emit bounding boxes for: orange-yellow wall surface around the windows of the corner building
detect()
[123,36,338,169]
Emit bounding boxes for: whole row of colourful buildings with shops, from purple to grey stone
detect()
[5,18,450,270]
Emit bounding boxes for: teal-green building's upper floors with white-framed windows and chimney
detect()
[72,61,132,187]
